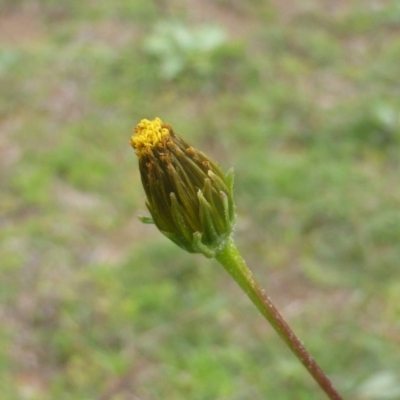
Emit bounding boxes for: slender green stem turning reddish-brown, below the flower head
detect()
[215,239,343,400]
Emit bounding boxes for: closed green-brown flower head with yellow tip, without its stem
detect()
[130,118,235,257]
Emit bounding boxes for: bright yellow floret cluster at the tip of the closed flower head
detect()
[130,118,169,154]
